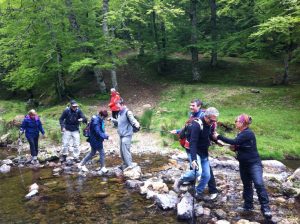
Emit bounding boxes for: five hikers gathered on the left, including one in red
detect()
[20,88,140,173]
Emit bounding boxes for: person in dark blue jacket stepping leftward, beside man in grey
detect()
[78,110,109,174]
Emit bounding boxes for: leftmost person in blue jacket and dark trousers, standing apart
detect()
[20,109,45,164]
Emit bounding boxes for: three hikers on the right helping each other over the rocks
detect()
[170,99,272,219]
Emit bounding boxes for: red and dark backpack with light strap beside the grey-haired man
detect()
[178,117,203,149]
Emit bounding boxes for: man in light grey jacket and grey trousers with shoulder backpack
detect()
[111,98,140,169]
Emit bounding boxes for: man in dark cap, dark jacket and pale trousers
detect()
[59,100,87,162]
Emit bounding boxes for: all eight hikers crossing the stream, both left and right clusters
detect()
[20,92,272,219]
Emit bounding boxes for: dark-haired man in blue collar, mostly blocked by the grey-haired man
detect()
[170,99,219,200]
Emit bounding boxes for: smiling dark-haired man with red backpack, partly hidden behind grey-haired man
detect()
[170,99,219,200]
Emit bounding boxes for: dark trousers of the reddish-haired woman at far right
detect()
[240,161,270,211]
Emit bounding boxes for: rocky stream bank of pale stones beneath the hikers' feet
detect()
[0,135,300,224]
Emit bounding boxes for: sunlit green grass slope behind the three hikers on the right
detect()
[152,84,300,159]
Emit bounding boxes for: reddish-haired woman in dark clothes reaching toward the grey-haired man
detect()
[214,114,272,219]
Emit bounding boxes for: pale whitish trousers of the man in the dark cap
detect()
[62,130,80,158]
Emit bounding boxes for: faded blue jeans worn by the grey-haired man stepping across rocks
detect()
[181,154,211,194]
